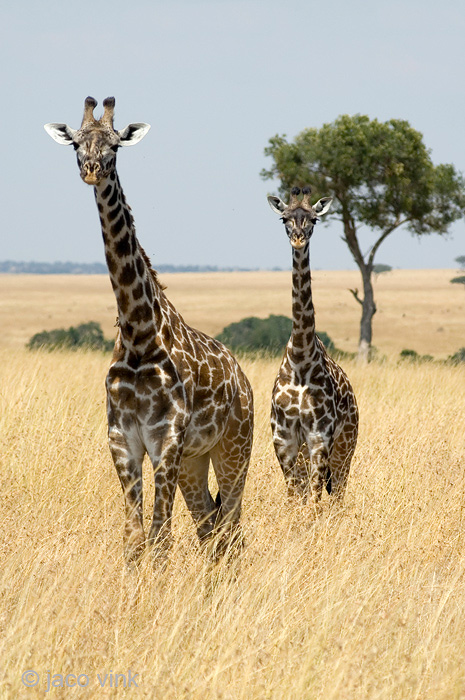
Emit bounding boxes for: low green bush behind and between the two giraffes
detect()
[216,314,336,355]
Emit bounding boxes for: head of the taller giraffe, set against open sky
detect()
[44,97,150,185]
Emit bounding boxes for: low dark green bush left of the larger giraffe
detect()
[26,321,114,352]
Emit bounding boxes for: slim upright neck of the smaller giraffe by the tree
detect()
[290,243,317,361]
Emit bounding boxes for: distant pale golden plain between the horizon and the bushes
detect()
[0,270,465,358]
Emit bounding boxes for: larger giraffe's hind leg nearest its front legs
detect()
[178,453,218,543]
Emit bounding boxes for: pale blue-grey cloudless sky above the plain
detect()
[0,0,465,269]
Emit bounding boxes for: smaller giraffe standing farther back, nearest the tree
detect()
[268,187,358,505]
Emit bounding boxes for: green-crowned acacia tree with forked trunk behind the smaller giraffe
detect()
[261,115,465,360]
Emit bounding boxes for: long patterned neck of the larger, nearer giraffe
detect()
[94,171,163,355]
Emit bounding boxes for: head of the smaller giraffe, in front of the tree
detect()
[268,187,333,249]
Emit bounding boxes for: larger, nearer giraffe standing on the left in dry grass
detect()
[45,97,253,563]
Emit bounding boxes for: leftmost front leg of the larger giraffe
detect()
[108,428,145,565]
